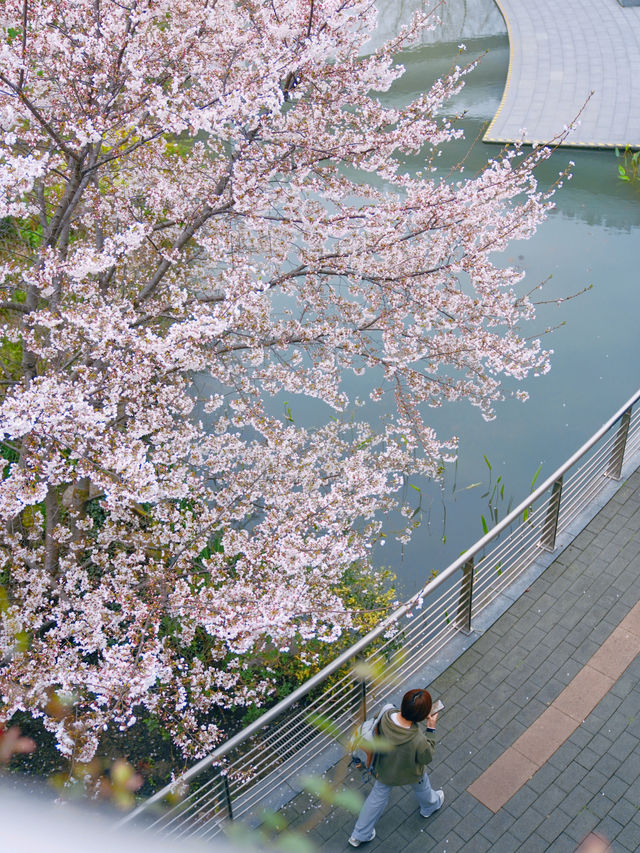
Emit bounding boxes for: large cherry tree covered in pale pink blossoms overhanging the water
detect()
[0,0,549,760]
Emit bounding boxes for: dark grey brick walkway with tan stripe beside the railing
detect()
[284,470,640,853]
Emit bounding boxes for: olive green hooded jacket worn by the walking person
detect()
[377,708,436,785]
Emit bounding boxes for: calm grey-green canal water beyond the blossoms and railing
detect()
[359,0,640,597]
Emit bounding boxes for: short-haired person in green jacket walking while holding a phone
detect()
[349,690,444,847]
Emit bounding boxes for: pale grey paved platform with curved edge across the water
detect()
[484,0,640,148]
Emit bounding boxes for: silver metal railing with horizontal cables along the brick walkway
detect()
[123,390,640,839]
